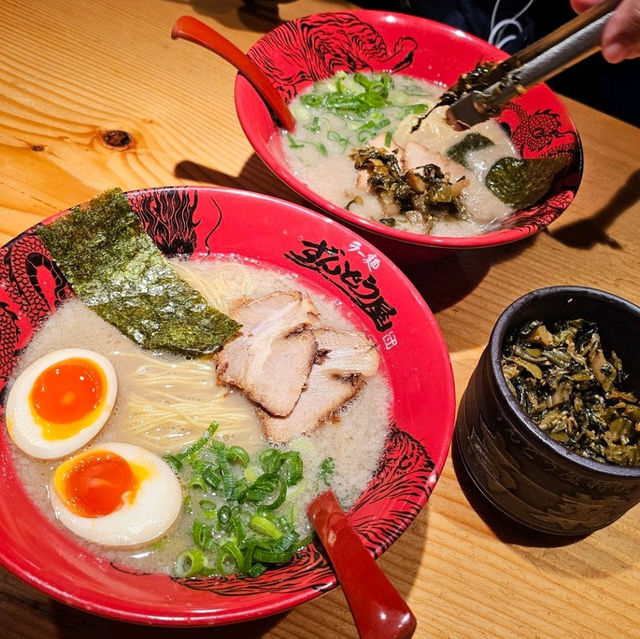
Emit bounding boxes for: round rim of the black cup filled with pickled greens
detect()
[487,285,640,480]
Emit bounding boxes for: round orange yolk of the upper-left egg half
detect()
[29,358,107,439]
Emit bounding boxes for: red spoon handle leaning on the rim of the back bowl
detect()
[171,16,296,131]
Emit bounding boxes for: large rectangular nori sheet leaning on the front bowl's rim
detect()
[37,189,240,357]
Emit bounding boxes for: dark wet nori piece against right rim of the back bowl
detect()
[486,155,570,209]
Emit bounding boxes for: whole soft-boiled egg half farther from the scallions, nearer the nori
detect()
[6,348,118,459]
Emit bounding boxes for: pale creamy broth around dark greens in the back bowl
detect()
[278,73,519,237]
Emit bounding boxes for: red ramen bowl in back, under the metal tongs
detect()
[235,11,582,261]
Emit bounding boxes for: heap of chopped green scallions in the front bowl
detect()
[173,424,312,578]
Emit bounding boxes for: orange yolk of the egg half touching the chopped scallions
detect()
[53,450,148,517]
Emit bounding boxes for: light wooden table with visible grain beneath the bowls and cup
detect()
[0,0,640,639]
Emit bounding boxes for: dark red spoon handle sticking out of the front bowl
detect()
[307,490,416,639]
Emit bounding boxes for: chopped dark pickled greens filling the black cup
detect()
[501,318,640,466]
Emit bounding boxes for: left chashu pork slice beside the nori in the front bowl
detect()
[217,291,318,416]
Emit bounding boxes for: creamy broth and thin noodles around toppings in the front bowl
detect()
[7,259,391,572]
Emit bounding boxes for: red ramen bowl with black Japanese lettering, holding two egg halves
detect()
[0,187,455,626]
